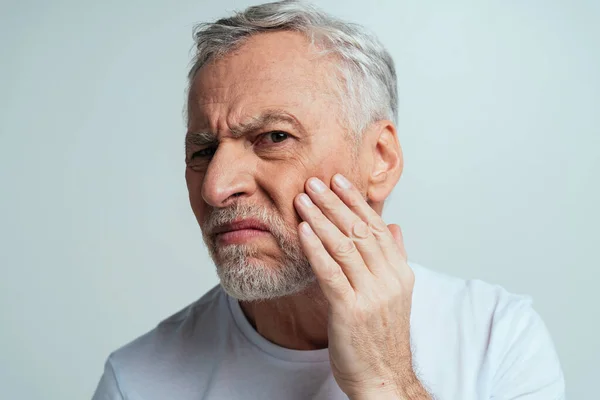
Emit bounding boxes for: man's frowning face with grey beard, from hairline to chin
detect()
[186,32,359,300]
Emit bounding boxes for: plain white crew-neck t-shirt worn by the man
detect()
[94,262,565,400]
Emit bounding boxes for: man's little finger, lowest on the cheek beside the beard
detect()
[298,221,354,306]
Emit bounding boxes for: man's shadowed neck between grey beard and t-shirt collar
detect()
[240,282,328,350]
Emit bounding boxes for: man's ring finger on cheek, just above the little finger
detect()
[294,193,371,290]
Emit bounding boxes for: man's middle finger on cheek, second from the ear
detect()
[306,178,385,273]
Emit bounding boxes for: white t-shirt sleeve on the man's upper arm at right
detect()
[490,298,565,400]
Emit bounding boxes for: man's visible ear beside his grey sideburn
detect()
[367,120,404,209]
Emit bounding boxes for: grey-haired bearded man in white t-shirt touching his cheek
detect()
[94,1,564,400]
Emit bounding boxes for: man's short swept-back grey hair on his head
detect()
[188,0,398,138]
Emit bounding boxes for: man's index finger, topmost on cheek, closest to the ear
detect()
[331,174,401,264]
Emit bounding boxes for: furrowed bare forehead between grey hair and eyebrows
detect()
[188,32,339,124]
